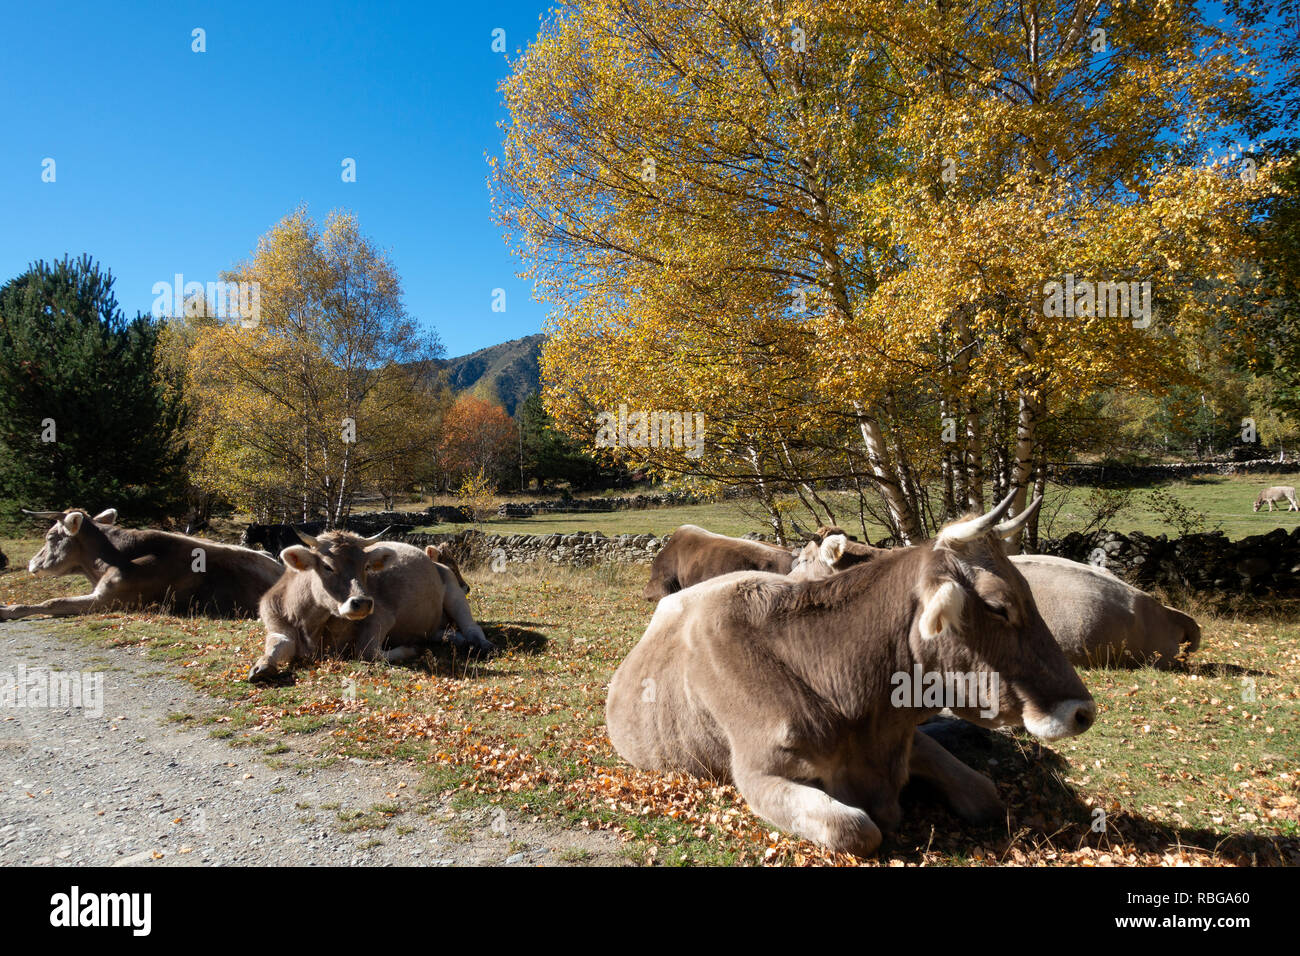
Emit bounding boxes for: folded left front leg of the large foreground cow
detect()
[732,765,881,856]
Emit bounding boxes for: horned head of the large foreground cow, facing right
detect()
[910,496,1096,740]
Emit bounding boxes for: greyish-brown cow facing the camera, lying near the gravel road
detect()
[248,531,495,682]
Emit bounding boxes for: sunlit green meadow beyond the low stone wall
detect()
[408,475,1300,541]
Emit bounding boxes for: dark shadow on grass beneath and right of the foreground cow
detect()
[881,721,1300,866]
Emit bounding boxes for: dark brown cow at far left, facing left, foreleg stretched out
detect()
[0,509,283,620]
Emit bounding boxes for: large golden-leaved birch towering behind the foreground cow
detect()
[494,0,1270,541]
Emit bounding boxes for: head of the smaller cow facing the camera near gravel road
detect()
[287,531,397,620]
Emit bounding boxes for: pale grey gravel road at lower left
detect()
[0,622,628,866]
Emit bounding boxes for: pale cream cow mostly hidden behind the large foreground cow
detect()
[790,536,1201,670]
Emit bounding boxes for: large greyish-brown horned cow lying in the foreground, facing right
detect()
[605,498,1096,853]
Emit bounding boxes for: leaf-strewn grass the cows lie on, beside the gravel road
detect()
[0,541,1300,865]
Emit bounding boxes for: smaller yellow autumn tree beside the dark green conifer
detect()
[167,209,439,527]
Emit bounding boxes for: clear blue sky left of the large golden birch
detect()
[0,0,549,355]
